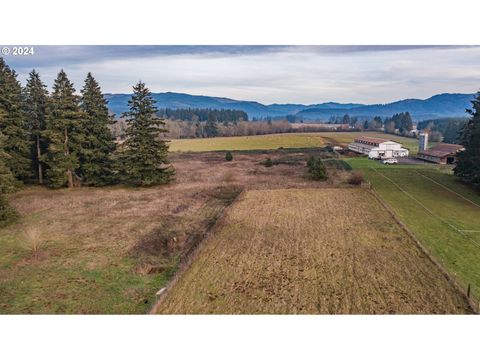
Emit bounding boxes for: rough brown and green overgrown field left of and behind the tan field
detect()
[0,151,342,313]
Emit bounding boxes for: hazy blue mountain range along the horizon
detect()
[105,92,474,121]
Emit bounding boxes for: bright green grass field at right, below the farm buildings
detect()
[347,165,480,299]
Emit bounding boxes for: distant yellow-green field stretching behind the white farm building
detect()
[170,132,428,154]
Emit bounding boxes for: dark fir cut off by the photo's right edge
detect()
[454,91,480,187]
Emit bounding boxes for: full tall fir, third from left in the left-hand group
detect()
[43,70,85,188]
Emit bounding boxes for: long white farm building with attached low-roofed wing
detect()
[348,136,408,159]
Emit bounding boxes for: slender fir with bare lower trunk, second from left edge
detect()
[25,70,48,184]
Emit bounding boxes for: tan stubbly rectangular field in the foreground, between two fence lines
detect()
[156,189,469,314]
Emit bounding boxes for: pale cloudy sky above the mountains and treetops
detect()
[4,45,480,104]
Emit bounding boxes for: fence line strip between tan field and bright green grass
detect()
[367,187,480,314]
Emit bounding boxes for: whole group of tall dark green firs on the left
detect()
[0,58,174,225]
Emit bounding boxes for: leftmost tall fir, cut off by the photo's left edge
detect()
[0,58,33,181]
